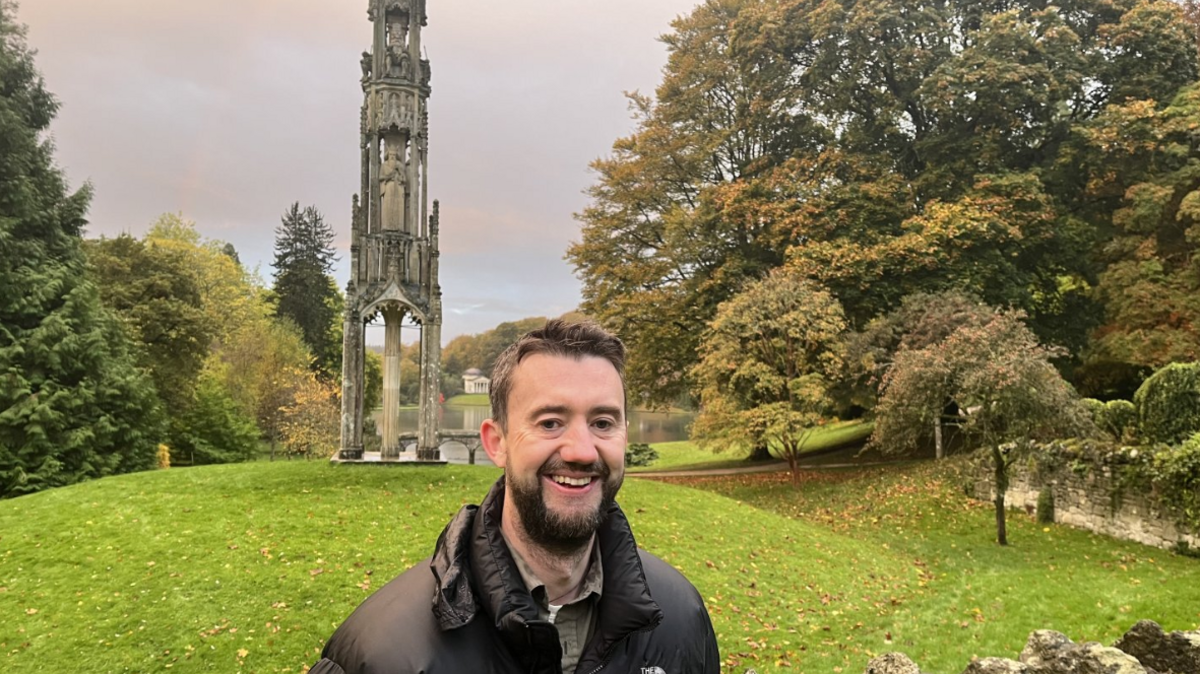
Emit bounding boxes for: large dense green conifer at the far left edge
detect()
[0,0,162,497]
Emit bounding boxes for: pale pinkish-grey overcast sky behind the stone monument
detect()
[17,0,696,341]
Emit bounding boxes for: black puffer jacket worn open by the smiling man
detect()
[310,477,720,674]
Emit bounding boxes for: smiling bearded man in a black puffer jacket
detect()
[310,320,720,674]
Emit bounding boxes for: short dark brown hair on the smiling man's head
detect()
[488,318,625,428]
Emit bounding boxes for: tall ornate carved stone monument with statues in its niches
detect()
[336,0,442,461]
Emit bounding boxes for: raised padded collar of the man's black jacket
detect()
[430,475,662,669]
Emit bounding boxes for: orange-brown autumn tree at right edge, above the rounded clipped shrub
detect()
[1080,85,1200,398]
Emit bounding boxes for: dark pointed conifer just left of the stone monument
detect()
[272,201,342,373]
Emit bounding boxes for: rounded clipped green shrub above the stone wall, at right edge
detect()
[1133,362,1200,445]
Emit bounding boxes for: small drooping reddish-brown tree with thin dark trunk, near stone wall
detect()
[871,311,1091,546]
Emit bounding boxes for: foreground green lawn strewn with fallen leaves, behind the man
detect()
[0,453,1200,674]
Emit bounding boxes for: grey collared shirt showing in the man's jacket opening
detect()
[504,538,604,674]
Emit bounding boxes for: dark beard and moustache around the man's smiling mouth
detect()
[505,457,625,555]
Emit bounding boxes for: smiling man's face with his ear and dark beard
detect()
[482,354,626,553]
